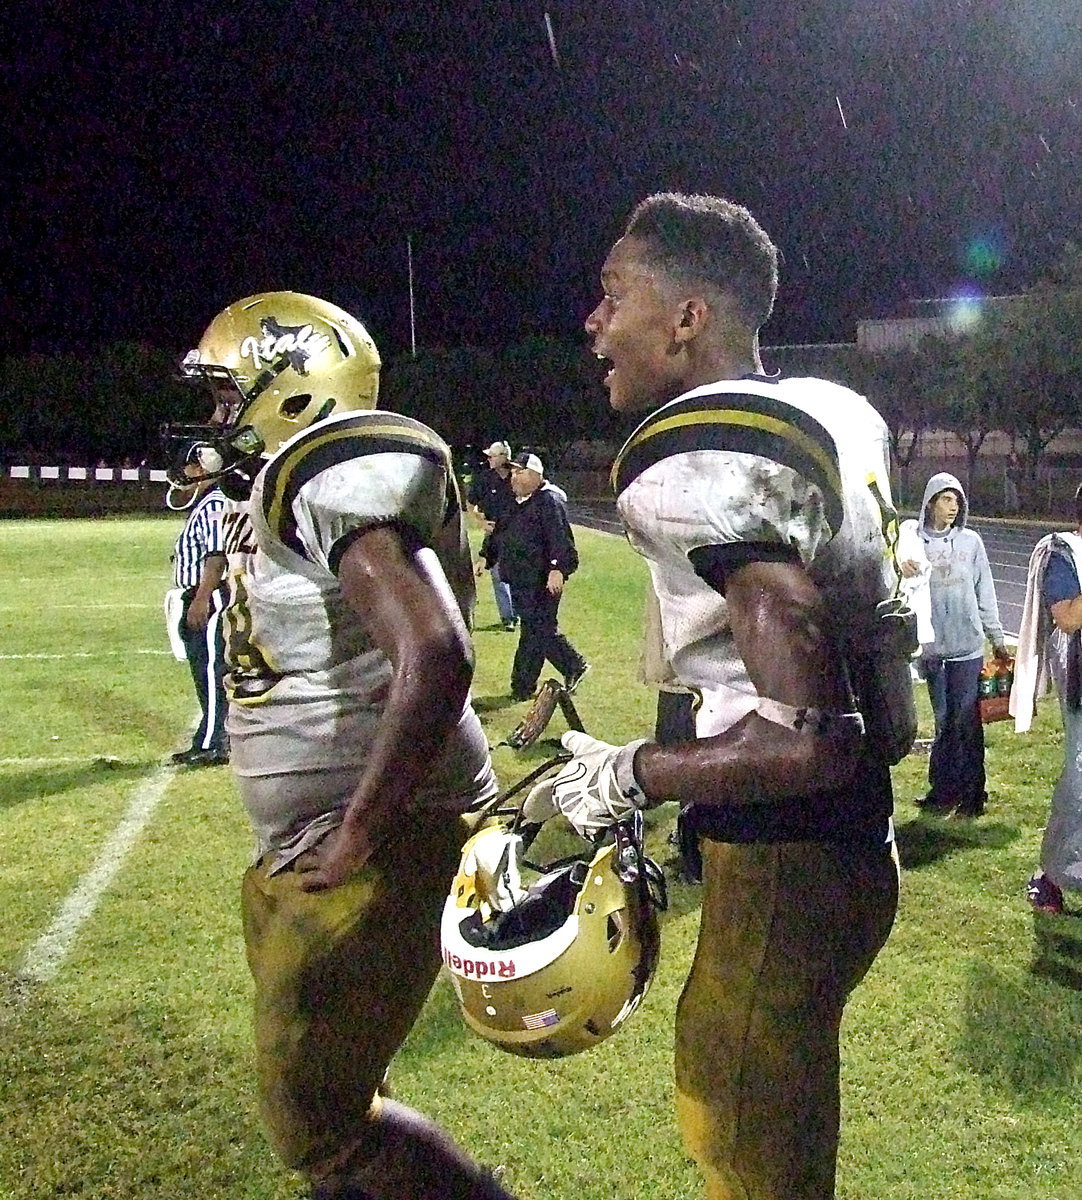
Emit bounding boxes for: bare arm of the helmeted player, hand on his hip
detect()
[302,527,473,892]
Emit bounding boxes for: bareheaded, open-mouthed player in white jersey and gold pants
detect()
[529,194,913,1200]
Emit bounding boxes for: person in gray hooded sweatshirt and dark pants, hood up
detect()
[916,472,1010,817]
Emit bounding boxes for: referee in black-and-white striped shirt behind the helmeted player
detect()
[172,463,229,767]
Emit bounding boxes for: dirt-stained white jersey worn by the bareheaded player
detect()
[612,377,897,737]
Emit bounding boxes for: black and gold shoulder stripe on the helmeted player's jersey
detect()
[263,409,457,556]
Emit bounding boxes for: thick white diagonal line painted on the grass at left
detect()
[19,767,175,983]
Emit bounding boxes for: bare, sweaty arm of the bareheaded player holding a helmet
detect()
[635,562,860,805]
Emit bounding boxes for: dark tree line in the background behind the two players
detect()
[0,248,1082,497]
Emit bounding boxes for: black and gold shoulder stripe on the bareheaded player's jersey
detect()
[611,391,843,530]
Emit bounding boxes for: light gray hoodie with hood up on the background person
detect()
[919,470,1003,659]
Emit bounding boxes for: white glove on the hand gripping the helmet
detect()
[522,730,647,841]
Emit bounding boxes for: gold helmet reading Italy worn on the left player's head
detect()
[167,292,380,492]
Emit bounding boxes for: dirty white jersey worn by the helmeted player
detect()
[227,410,495,864]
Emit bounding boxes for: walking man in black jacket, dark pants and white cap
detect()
[497,454,587,701]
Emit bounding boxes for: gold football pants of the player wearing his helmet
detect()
[242,809,476,1172]
